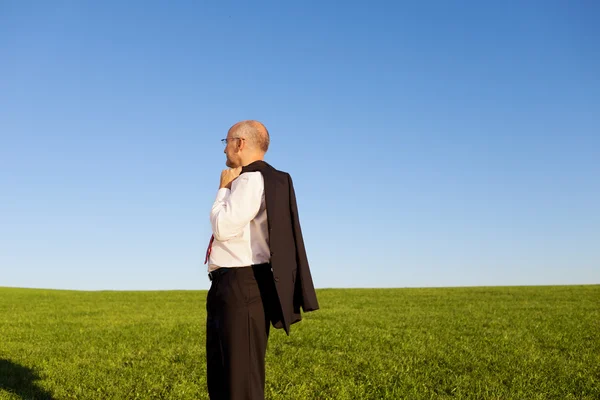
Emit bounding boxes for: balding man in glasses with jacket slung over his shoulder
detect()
[205,121,319,399]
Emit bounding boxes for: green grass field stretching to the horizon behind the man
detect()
[0,285,600,399]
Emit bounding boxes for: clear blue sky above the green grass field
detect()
[0,1,600,290]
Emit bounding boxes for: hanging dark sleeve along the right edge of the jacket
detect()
[288,174,319,312]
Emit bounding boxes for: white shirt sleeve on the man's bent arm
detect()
[210,172,264,242]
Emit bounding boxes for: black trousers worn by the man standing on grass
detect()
[206,264,278,400]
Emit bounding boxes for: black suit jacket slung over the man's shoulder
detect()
[241,161,319,335]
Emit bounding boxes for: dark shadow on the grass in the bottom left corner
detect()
[0,358,53,400]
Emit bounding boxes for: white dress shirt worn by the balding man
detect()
[208,171,271,272]
